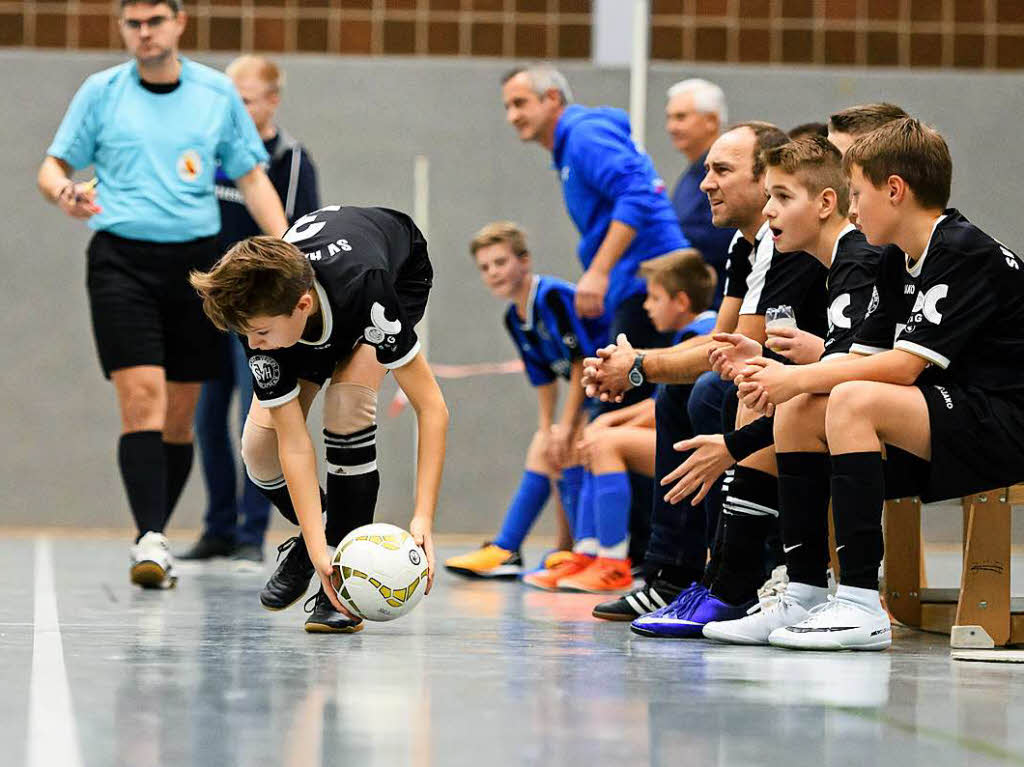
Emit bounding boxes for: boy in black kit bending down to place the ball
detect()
[191,205,449,633]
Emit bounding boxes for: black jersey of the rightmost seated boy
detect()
[852,209,1024,401]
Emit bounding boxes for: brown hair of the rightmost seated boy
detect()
[843,117,953,210]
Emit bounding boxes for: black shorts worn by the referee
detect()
[86,231,223,381]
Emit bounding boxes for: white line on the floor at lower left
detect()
[27,538,82,767]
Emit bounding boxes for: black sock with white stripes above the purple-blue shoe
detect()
[711,466,778,604]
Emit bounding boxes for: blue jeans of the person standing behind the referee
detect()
[196,336,270,546]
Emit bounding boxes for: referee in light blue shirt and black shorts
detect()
[38,0,288,588]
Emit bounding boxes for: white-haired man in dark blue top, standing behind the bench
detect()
[665,78,736,307]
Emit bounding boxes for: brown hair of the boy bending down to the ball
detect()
[188,237,313,333]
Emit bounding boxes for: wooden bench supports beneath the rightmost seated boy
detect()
[884,484,1024,648]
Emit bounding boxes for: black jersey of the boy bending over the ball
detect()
[243,205,430,408]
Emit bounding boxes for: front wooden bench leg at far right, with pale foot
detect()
[949,488,1011,647]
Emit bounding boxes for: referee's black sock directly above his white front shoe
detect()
[118,431,167,540]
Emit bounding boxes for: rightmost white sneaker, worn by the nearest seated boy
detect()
[768,586,893,650]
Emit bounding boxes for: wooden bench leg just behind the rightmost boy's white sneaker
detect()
[884,498,922,628]
